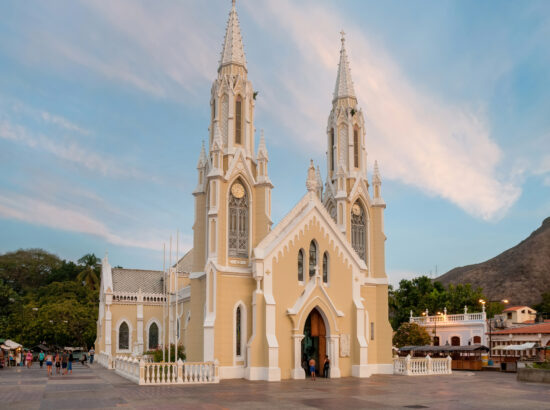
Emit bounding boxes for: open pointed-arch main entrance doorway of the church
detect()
[302,309,327,376]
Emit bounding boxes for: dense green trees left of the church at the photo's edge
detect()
[0,249,101,347]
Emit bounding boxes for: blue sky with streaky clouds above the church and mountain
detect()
[0,0,550,284]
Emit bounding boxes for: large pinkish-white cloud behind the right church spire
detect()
[247,0,521,219]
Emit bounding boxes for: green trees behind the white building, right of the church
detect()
[389,276,490,329]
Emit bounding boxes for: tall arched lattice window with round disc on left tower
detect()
[229,182,248,258]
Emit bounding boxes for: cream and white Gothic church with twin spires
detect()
[96,4,393,380]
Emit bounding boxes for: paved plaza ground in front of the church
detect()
[0,364,550,410]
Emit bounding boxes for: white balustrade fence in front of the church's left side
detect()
[104,354,220,386]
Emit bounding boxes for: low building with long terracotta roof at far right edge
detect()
[491,322,550,357]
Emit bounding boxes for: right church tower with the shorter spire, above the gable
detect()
[323,31,385,267]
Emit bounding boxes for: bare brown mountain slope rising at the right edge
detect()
[435,217,550,306]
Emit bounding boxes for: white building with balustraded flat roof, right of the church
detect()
[409,307,488,346]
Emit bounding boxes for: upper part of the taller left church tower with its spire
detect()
[193,1,273,272]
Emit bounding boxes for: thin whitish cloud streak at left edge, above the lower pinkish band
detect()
[0,117,154,180]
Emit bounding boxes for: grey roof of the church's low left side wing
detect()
[112,268,163,293]
